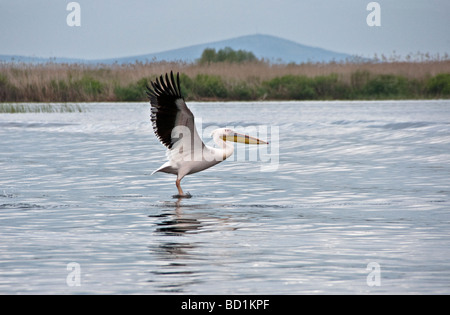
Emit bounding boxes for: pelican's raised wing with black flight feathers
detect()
[147,71,204,150]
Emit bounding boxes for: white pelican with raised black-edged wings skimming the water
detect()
[147,71,268,198]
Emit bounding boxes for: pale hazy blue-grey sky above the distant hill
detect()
[0,0,450,59]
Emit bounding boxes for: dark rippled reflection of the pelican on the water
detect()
[149,198,236,293]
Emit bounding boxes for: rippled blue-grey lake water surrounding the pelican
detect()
[0,101,450,294]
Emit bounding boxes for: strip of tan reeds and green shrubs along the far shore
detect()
[0,60,450,102]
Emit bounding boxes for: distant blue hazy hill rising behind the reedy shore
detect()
[0,35,353,64]
